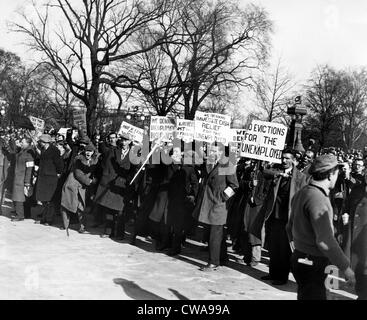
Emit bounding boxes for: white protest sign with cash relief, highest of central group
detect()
[195,111,231,145]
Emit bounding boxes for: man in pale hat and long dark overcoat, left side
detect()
[35,134,64,225]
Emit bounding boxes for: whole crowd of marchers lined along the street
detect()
[0,128,367,299]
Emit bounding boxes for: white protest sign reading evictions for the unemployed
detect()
[240,120,287,163]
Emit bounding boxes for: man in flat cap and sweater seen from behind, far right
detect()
[287,154,355,300]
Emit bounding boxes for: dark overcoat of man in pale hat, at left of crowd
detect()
[35,145,64,202]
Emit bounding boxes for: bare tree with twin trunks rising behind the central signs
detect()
[106,0,272,119]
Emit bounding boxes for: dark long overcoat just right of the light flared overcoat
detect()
[95,147,135,211]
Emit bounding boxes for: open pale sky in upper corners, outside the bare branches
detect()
[0,0,367,81]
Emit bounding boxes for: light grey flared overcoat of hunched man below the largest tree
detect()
[61,155,98,213]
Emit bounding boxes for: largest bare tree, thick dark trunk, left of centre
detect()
[12,0,169,133]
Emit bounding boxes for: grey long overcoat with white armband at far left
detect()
[12,148,35,202]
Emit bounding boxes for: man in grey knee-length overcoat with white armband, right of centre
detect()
[194,144,239,271]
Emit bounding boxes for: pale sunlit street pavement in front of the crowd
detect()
[0,195,356,300]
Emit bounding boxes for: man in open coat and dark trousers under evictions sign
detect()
[250,149,306,285]
